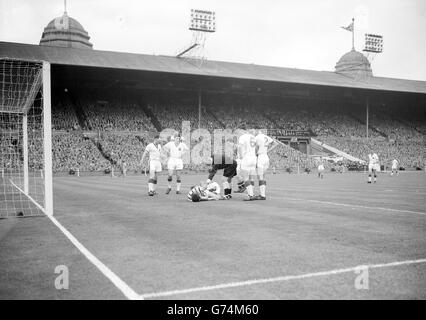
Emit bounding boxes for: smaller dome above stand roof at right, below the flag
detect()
[336,49,373,77]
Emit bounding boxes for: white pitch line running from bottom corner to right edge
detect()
[141,259,426,299]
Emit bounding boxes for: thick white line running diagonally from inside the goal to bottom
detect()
[10,180,143,300]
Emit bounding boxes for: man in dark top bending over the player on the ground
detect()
[207,153,244,196]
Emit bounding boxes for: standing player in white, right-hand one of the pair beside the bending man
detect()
[255,132,274,200]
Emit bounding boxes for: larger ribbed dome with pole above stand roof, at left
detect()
[40,11,93,49]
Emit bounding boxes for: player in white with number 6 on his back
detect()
[238,129,257,201]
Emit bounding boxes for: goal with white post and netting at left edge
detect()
[0,59,52,218]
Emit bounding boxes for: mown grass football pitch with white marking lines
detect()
[0,172,426,299]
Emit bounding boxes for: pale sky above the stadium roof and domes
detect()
[0,0,426,81]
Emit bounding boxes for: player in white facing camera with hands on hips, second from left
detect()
[163,137,189,194]
